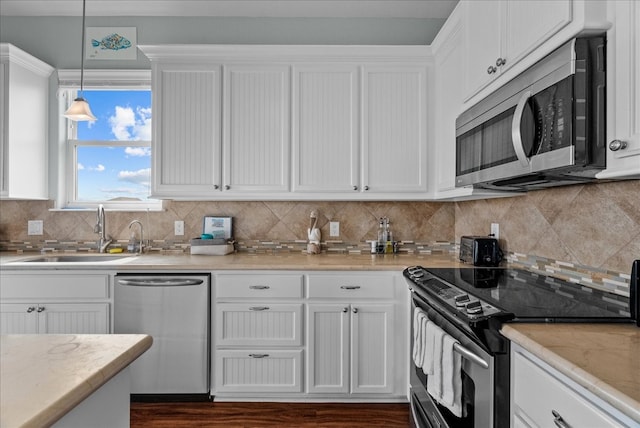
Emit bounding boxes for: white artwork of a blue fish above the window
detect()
[85,27,137,60]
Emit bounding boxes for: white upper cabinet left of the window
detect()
[0,43,54,199]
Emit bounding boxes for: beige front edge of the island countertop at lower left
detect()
[23,334,153,428]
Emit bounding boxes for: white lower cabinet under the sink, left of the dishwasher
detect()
[0,272,112,334]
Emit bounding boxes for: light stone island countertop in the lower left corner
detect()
[0,334,153,428]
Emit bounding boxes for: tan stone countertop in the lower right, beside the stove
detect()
[501,324,640,423]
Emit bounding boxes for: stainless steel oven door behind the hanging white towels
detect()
[410,290,495,428]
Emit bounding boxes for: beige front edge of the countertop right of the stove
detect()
[500,325,640,421]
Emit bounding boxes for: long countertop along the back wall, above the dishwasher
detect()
[0,253,462,271]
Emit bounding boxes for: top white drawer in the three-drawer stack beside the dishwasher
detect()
[216,275,303,299]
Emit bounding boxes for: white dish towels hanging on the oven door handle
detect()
[422,322,462,417]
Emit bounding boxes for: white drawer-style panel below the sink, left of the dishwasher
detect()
[0,272,109,301]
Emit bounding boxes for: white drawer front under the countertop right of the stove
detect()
[512,352,624,427]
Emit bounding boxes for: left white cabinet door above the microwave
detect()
[464,0,503,97]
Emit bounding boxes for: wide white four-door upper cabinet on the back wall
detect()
[139,45,431,200]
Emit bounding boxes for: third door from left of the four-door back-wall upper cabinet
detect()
[292,65,360,192]
